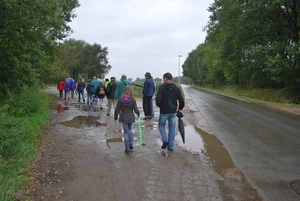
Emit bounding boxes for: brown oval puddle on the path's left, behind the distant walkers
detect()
[61,116,106,128]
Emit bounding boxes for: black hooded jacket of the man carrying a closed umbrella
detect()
[155,82,185,114]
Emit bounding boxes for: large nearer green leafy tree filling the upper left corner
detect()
[0,0,79,94]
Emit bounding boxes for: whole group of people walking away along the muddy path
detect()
[57,72,185,154]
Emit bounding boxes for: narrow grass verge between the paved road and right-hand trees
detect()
[194,86,300,107]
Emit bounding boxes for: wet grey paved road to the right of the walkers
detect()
[183,85,300,201]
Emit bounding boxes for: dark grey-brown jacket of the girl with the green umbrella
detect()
[114,96,140,123]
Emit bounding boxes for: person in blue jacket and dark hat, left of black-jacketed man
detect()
[142,72,155,120]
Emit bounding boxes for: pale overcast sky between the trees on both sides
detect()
[69,0,214,80]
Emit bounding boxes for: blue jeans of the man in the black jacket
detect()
[158,113,176,149]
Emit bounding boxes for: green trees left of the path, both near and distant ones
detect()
[0,0,111,98]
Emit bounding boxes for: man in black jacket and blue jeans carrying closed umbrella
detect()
[155,73,185,151]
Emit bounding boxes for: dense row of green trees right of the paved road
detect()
[182,0,300,103]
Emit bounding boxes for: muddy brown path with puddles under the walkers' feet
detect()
[31,87,261,201]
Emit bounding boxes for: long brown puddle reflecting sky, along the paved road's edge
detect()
[176,125,261,200]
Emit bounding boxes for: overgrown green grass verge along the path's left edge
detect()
[0,89,50,201]
